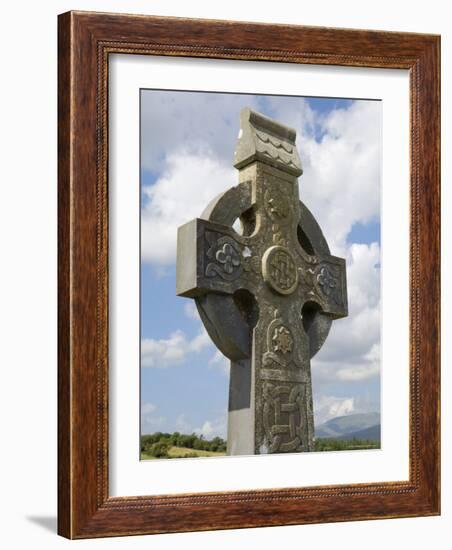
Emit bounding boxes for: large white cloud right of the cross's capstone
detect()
[297,101,381,255]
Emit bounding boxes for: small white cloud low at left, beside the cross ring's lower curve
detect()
[141,328,212,368]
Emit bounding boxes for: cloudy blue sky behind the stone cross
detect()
[141,90,381,438]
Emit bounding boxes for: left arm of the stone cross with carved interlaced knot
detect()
[176,218,252,298]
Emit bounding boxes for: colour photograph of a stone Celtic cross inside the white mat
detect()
[139,89,384,460]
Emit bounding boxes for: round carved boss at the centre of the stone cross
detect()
[262,245,298,294]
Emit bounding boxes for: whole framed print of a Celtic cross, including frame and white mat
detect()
[58,12,440,538]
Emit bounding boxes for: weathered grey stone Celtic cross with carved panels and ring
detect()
[177,108,347,455]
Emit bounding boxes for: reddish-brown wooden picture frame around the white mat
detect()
[58,12,440,538]
